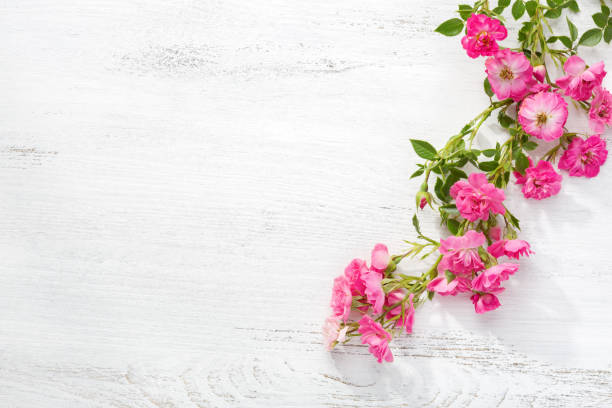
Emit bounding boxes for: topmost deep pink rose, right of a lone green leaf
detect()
[461,14,508,58]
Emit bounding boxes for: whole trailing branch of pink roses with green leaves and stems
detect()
[323,0,612,363]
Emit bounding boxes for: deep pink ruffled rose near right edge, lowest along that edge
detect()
[559,135,608,177]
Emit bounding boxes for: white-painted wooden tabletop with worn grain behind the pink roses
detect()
[0,0,612,408]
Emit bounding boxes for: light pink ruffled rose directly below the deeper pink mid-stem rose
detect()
[438,230,487,276]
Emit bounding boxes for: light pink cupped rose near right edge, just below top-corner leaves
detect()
[556,55,606,101]
